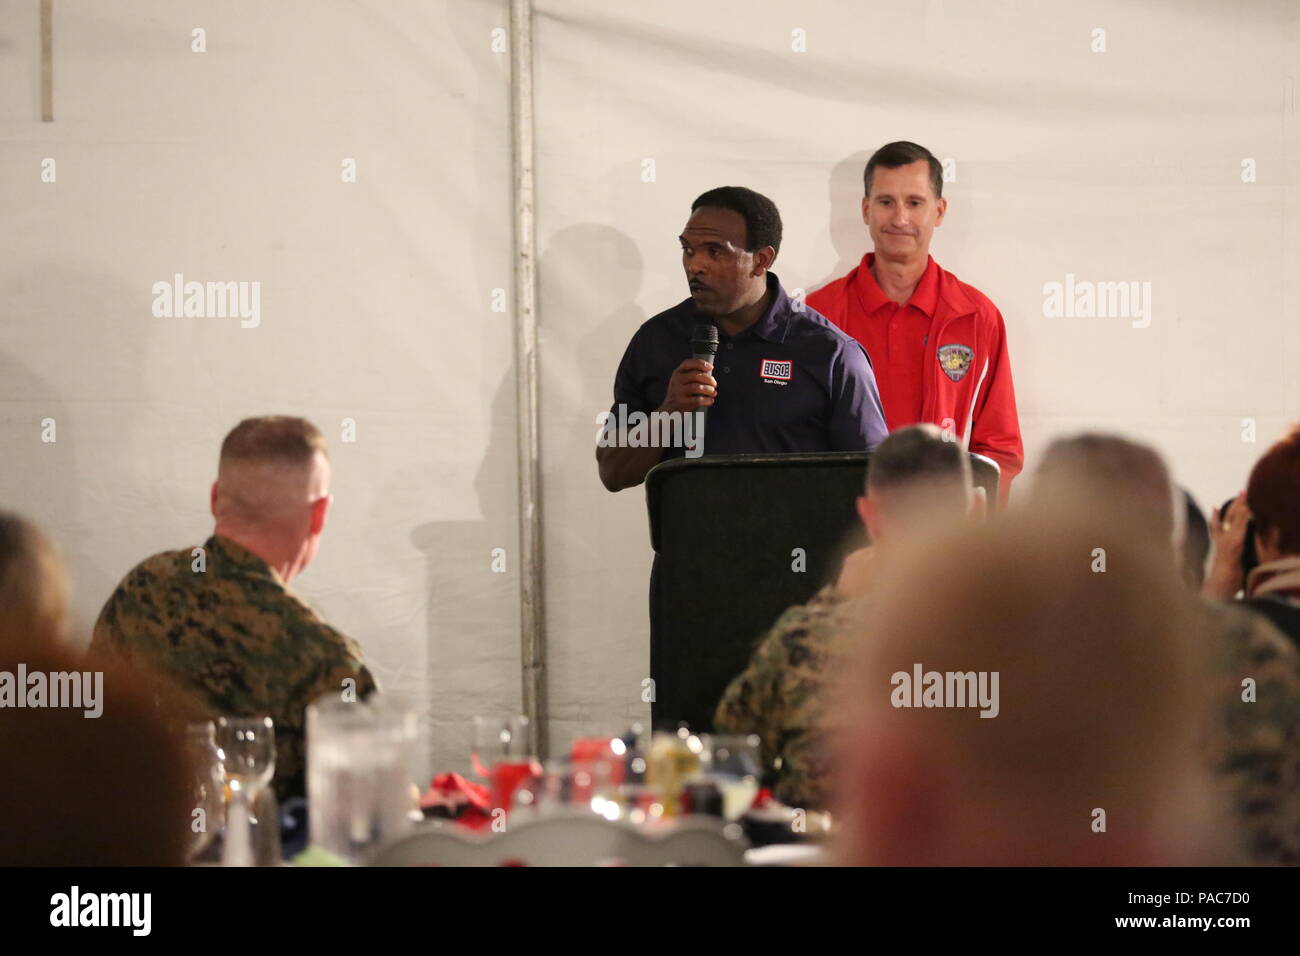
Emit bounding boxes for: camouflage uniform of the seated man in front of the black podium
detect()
[714,584,854,809]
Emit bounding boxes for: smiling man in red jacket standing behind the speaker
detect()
[807,142,1024,503]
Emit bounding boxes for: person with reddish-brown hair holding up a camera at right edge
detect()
[1205,425,1300,645]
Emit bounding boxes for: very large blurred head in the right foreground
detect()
[835,498,1214,865]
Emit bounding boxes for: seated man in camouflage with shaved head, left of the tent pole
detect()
[91,416,374,800]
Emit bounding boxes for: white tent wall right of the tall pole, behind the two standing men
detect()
[536,0,1300,740]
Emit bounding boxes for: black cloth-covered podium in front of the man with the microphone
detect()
[646,451,998,731]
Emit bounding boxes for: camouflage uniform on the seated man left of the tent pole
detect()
[91,536,376,801]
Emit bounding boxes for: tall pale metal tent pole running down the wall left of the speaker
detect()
[510,0,549,758]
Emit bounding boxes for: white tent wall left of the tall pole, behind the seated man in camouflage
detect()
[0,0,519,780]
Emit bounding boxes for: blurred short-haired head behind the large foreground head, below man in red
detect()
[1034,432,1187,561]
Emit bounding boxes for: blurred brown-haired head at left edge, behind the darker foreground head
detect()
[0,511,69,655]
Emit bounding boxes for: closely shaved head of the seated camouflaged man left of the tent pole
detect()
[212,415,330,564]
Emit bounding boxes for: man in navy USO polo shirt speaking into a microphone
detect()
[595,186,887,492]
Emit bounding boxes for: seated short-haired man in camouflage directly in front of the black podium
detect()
[714,424,983,809]
